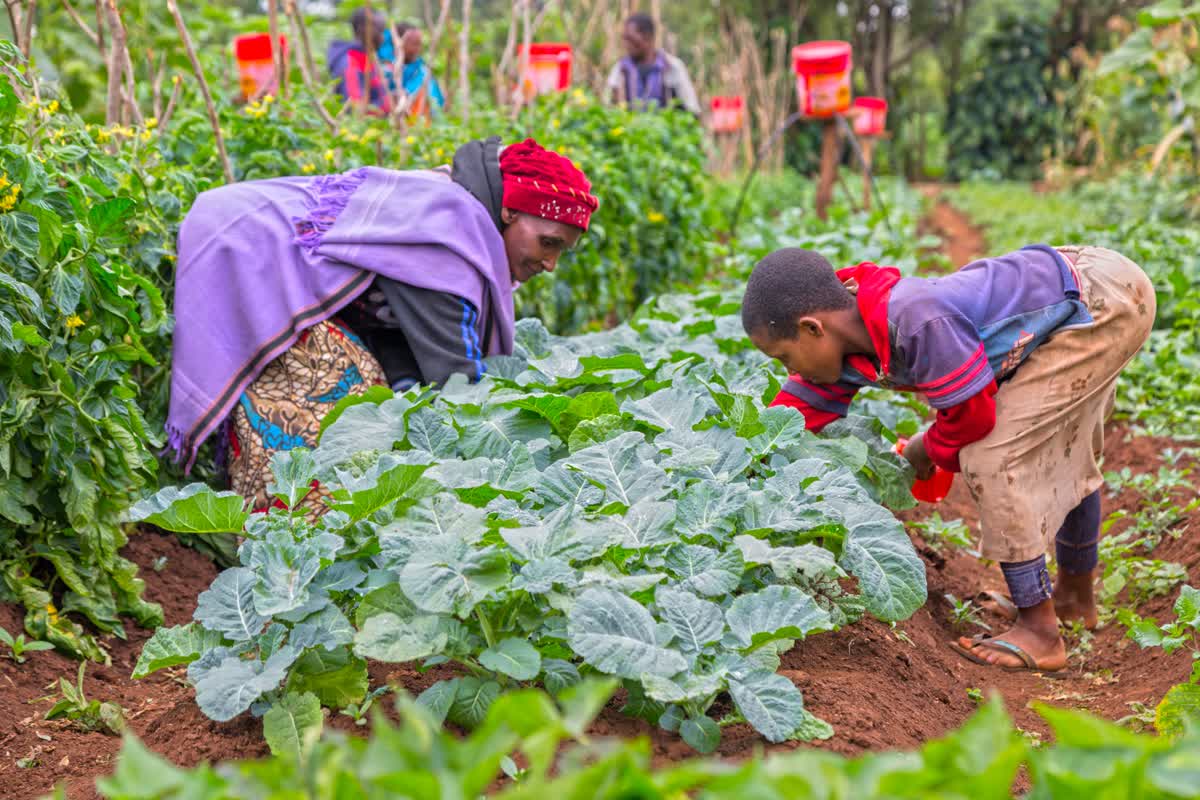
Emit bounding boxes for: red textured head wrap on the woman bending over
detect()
[500,139,600,230]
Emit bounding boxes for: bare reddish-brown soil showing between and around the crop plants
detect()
[0,190,1200,800]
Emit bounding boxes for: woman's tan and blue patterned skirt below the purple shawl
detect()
[228,320,388,515]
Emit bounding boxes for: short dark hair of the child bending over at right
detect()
[742,247,854,341]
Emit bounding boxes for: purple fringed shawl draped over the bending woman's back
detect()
[167,167,514,470]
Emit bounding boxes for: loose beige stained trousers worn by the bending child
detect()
[959,246,1156,561]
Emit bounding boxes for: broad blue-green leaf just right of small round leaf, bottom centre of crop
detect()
[566,589,688,678]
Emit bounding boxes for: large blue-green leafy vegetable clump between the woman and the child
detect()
[133,294,925,752]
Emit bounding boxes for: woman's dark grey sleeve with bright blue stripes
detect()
[378,279,485,385]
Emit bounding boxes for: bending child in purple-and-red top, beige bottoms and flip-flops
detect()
[742,245,1156,672]
